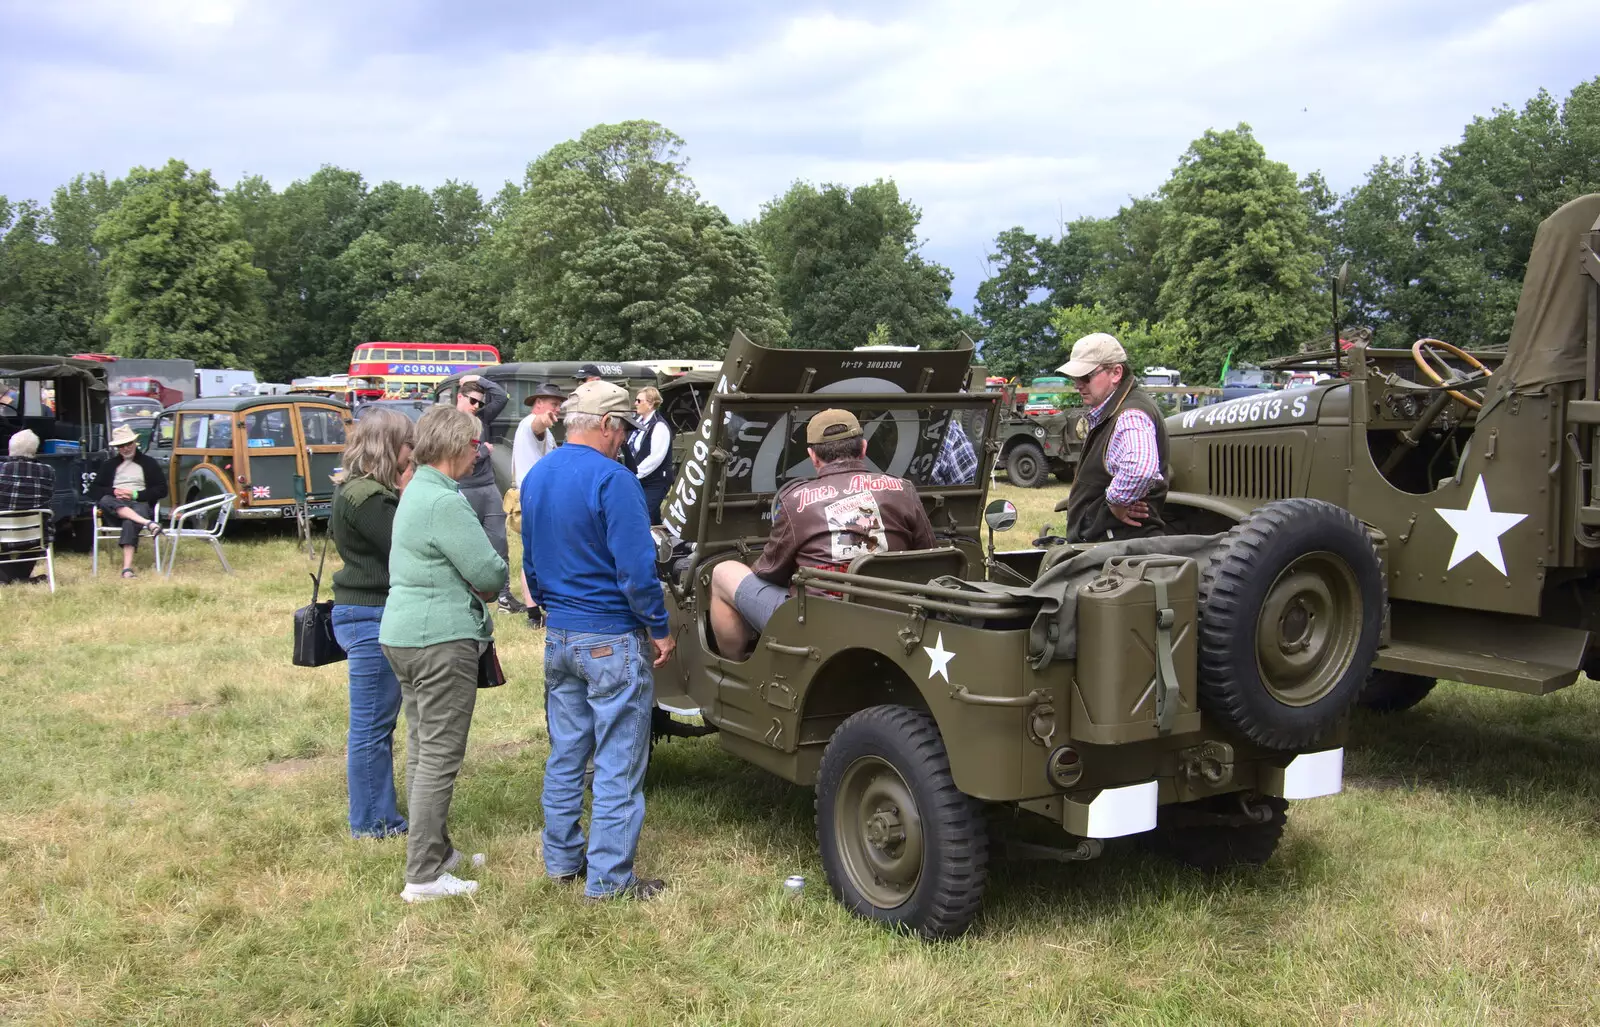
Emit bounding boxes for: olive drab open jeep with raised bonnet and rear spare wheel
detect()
[656,327,1363,937]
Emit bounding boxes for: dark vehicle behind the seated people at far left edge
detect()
[0,355,110,529]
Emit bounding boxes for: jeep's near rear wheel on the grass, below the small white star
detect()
[816,705,989,939]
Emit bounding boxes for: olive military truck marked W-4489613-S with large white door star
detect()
[1166,195,1600,710]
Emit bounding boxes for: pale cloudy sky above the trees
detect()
[0,0,1600,306]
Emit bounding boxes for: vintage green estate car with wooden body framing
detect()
[146,395,350,520]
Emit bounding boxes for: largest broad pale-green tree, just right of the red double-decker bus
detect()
[485,122,784,360]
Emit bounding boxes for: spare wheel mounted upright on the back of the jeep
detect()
[1197,499,1387,749]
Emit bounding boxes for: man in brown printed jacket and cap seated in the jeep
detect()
[710,410,934,659]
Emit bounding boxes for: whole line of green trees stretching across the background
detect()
[0,78,1600,381]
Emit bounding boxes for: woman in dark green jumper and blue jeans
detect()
[328,410,411,838]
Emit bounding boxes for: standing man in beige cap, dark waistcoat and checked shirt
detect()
[1059,331,1171,542]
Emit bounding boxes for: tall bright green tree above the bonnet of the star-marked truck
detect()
[1157,125,1323,374]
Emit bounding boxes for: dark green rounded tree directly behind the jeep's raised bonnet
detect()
[754,179,965,349]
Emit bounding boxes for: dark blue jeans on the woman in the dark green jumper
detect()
[333,606,406,838]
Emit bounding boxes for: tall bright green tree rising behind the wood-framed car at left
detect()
[94,160,266,366]
